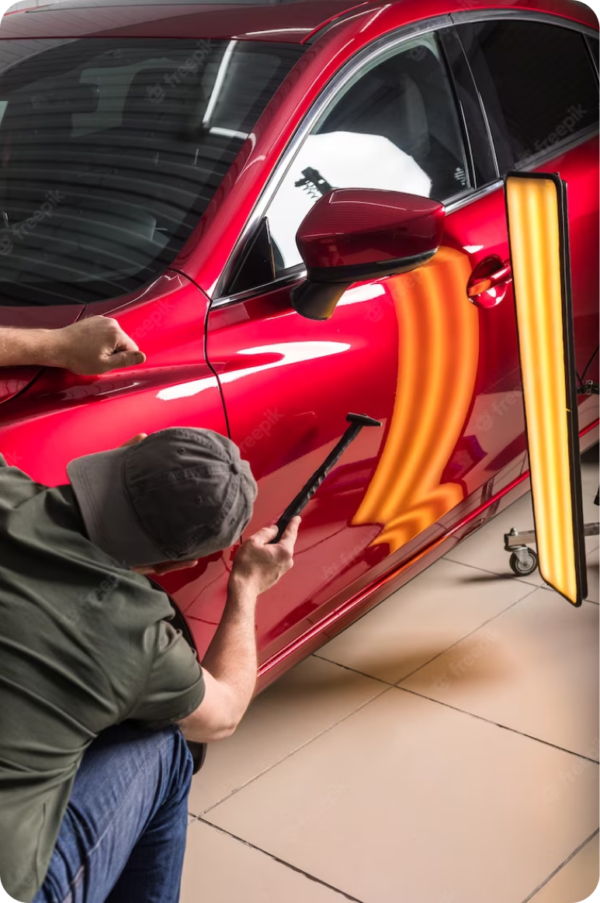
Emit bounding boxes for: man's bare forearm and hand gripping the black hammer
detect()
[180,517,300,743]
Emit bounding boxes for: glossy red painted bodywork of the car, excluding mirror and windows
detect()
[0,0,600,687]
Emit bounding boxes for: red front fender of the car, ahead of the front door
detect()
[0,273,233,653]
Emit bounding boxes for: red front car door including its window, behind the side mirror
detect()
[207,26,524,662]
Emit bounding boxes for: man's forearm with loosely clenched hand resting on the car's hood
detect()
[0,317,146,376]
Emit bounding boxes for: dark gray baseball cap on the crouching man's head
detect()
[67,427,257,567]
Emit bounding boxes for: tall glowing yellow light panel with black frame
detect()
[506,173,587,605]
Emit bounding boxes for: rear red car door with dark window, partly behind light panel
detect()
[458,13,600,438]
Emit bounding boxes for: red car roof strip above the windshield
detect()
[0,0,385,43]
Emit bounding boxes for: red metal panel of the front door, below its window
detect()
[208,226,524,660]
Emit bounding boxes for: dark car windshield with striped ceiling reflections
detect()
[0,38,303,305]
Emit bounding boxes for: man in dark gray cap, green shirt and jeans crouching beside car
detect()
[0,428,300,903]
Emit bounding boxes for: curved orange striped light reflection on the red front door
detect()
[352,248,479,552]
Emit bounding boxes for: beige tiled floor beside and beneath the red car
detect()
[182,450,600,903]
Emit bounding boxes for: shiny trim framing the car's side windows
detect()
[210,9,600,310]
